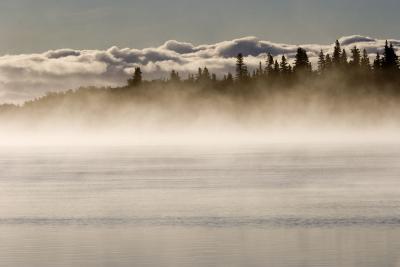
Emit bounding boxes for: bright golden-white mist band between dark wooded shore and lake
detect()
[0,84,400,146]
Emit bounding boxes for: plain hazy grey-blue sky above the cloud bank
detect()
[0,0,400,54]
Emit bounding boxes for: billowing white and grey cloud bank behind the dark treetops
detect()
[0,35,400,103]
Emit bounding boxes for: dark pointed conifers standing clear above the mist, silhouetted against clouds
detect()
[128,38,400,93]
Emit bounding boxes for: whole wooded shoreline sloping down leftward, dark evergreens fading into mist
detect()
[0,38,400,117]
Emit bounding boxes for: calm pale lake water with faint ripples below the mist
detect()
[0,144,400,267]
